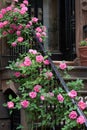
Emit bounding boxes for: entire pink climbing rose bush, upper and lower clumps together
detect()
[0,0,87,130]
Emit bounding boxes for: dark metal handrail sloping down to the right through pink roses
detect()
[38,42,87,127]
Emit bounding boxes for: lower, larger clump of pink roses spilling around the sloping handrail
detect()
[6,49,87,130]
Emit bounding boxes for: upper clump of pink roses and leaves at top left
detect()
[0,0,46,47]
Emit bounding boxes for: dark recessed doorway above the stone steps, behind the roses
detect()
[30,0,76,61]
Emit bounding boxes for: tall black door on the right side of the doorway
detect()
[59,0,76,60]
